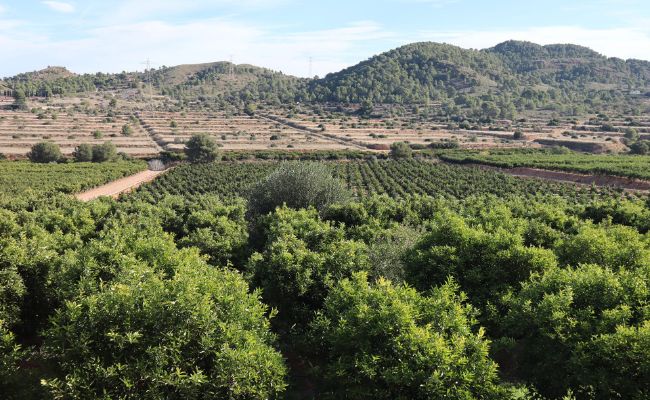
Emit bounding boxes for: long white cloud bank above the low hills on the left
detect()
[0,18,391,76]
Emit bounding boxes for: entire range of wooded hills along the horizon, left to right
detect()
[6,41,650,118]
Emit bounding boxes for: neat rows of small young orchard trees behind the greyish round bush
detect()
[133,159,618,204]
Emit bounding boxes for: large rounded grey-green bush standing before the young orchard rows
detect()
[249,162,350,215]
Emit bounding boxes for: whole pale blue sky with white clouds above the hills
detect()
[0,0,650,77]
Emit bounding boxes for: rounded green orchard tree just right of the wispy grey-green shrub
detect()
[405,213,557,305]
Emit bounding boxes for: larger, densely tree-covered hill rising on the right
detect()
[298,41,650,113]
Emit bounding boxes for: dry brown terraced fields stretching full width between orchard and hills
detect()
[0,95,650,157]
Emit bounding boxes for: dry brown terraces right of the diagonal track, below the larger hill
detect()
[269,106,650,153]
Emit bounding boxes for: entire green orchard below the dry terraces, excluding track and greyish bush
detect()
[0,153,650,400]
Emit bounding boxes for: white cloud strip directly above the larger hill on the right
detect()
[420,25,650,60]
